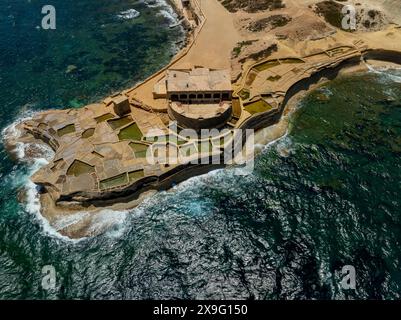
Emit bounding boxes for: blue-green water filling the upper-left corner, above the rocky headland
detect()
[0,0,184,117]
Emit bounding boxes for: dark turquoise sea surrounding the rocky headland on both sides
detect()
[0,0,401,299]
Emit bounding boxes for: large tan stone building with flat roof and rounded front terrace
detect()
[153,67,233,129]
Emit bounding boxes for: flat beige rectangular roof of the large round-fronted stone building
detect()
[166,68,232,92]
